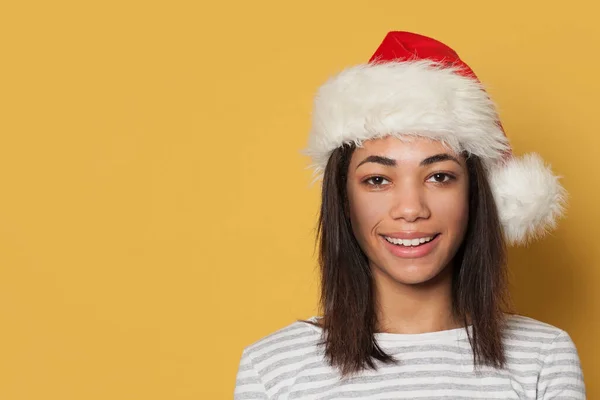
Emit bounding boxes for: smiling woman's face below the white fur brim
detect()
[347,136,469,285]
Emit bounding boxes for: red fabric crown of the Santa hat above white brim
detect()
[369,31,477,79]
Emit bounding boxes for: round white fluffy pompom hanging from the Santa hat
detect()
[489,153,567,245]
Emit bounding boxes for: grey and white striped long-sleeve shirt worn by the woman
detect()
[234,315,585,400]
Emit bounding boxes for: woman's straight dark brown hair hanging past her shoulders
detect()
[300,144,510,377]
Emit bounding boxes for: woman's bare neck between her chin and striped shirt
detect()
[372,266,463,334]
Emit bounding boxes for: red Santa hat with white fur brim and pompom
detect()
[303,32,567,244]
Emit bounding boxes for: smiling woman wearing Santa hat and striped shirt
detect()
[235,32,585,399]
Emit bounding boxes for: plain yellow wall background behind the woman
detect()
[0,0,600,400]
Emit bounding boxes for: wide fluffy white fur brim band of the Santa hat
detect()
[302,59,510,178]
